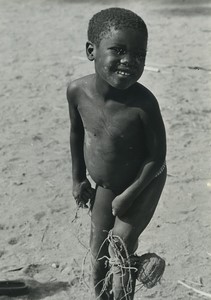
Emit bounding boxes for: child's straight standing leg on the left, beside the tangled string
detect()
[90,186,115,300]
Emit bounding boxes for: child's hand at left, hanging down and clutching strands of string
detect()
[73,178,95,208]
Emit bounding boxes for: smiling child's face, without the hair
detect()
[88,28,147,90]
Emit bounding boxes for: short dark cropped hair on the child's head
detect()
[88,7,148,46]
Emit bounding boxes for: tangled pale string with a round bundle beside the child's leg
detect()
[95,231,165,299]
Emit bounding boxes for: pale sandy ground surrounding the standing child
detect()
[0,0,211,300]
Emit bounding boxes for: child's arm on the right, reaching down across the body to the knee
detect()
[112,96,166,216]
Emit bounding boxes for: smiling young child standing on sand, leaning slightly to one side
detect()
[67,8,166,300]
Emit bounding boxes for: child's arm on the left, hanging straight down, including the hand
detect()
[67,85,93,206]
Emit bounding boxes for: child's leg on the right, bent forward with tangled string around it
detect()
[109,169,166,300]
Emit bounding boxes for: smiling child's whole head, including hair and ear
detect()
[86,8,148,89]
